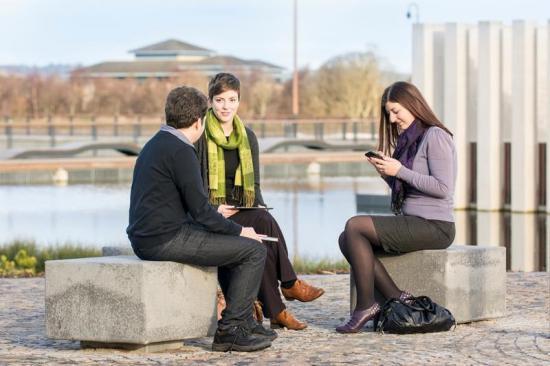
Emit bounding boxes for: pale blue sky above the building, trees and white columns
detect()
[0,0,550,73]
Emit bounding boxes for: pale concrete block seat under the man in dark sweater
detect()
[46,256,218,352]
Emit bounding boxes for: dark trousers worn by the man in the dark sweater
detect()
[134,225,267,330]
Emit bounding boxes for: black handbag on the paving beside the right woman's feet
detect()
[375,296,456,334]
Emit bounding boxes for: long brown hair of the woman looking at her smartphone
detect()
[378,81,453,155]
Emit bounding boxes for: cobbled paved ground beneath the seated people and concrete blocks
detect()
[0,273,550,365]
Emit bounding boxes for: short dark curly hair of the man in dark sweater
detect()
[164,86,208,128]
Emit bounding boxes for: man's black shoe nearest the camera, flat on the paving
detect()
[212,326,271,352]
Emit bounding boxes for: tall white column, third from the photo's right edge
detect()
[476,22,502,210]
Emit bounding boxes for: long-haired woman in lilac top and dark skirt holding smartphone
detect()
[336,81,456,333]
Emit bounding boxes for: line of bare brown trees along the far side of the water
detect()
[0,48,383,118]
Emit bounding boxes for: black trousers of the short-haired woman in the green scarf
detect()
[230,210,296,318]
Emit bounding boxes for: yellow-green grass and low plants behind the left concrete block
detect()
[0,240,101,277]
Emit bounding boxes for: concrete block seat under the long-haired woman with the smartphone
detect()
[350,245,506,323]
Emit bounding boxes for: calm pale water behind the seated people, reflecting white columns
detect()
[0,177,550,271]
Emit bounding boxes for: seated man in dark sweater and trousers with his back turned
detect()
[127,87,277,352]
